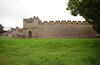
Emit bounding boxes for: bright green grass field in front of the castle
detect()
[0,38,100,65]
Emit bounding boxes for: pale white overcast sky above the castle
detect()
[0,0,84,29]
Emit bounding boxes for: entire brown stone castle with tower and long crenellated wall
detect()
[9,17,96,38]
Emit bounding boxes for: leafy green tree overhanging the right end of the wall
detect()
[67,0,100,33]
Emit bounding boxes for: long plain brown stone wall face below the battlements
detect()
[37,25,95,38]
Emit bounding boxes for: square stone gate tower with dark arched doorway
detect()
[22,16,42,38]
